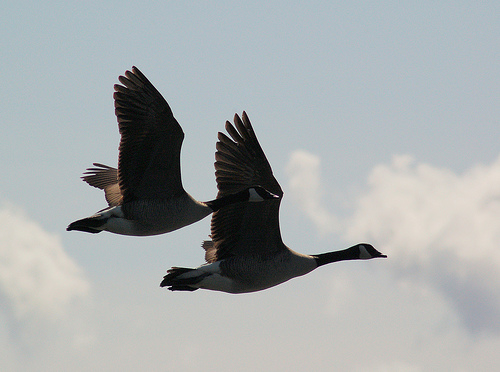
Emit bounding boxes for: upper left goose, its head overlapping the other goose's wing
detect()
[66,66,277,236]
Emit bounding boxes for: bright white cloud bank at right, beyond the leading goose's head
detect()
[287,151,500,334]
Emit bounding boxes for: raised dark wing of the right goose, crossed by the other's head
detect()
[203,112,284,262]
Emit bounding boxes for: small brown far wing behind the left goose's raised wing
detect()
[82,163,123,207]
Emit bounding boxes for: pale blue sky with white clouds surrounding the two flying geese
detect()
[0,0,500,372]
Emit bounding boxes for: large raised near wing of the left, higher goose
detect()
[113,67,184,202]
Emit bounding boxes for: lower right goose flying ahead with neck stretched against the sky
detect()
[160,112,387,293]
